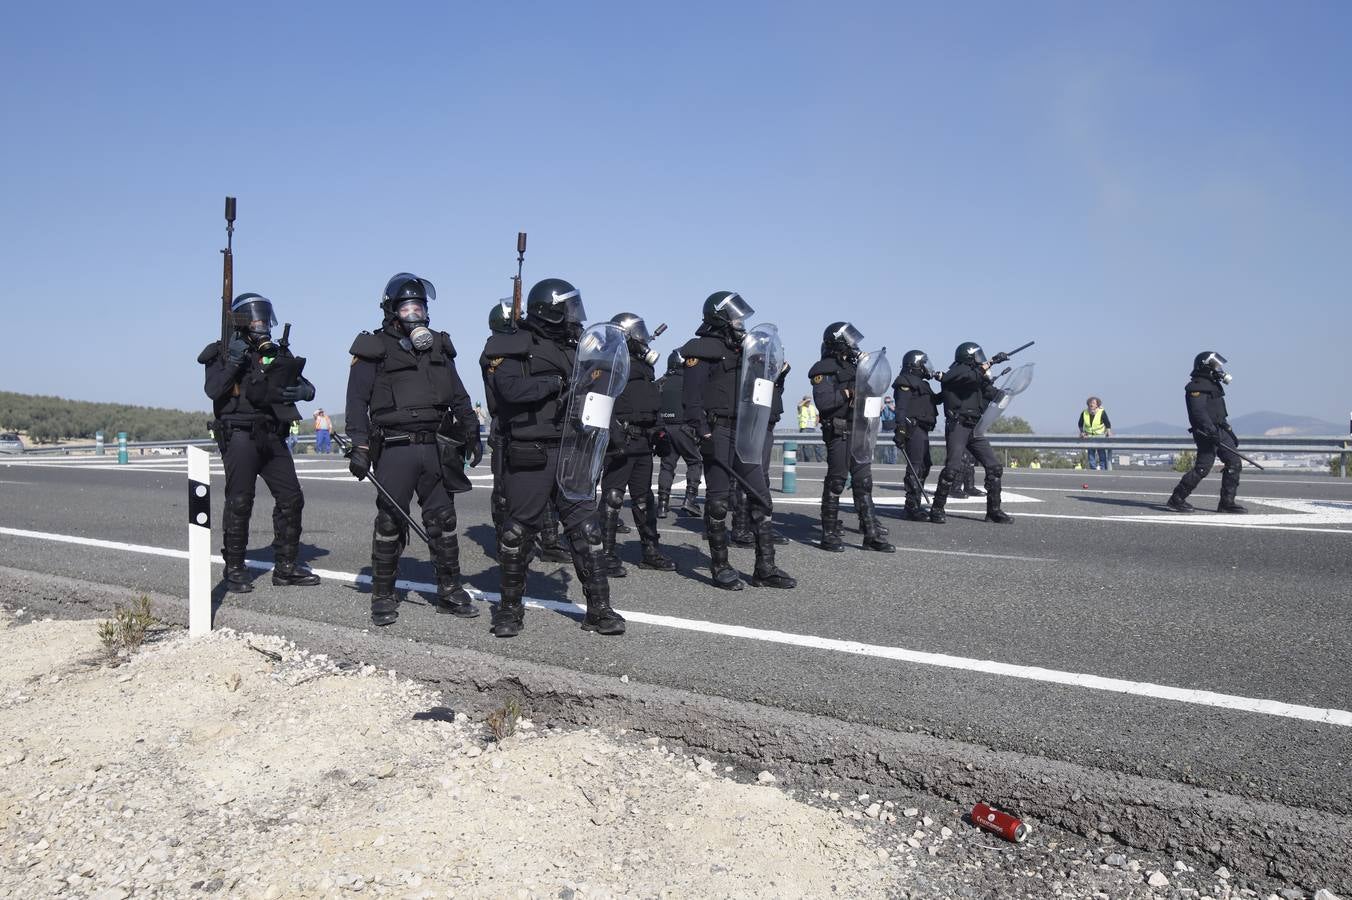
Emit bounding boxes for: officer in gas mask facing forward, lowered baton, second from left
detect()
[346,272,483,626]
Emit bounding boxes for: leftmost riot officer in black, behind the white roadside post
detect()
[197,293,319,593]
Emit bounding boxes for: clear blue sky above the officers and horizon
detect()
[0,1,1352,432]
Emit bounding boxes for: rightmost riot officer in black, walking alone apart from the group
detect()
[1168,350,1248,514]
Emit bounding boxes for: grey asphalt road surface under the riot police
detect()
[0,457,1352,812]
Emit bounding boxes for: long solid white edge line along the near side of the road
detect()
[0,527,1352,728]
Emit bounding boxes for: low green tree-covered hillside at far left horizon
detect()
[0,391,212,443]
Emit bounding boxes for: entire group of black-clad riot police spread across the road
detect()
[199,273,1244,638]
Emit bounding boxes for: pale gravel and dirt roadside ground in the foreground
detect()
[0,609,1333,900]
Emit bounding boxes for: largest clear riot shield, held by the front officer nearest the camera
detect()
[556,322,629,500]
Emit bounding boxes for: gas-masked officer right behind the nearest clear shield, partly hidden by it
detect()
[600,312,676,578]
